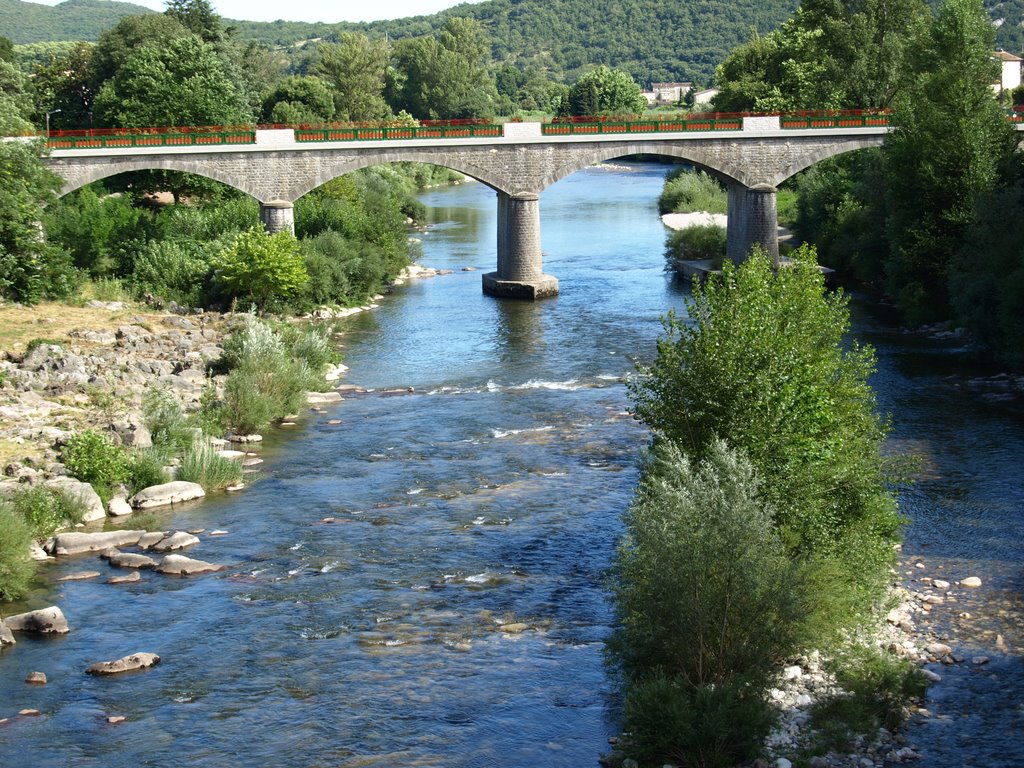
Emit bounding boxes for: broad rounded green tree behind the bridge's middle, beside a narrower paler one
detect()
[388,17,498,120]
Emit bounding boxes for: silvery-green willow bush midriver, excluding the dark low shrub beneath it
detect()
[608,440,804,687]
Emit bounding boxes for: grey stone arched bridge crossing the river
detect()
[45,117,888,299]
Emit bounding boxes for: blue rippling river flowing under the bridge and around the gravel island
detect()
[0,164,1024,768]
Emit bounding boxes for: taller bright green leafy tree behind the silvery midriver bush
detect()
[630,247,898,565]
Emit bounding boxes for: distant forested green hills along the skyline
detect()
[8,0,1024,85]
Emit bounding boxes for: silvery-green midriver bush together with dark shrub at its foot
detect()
[608,439,806,766]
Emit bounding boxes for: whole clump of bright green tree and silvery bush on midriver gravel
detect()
[608,249,902,768]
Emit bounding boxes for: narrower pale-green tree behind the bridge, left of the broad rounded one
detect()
[312,32,391,120]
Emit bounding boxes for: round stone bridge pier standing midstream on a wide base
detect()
[483,191,558,299]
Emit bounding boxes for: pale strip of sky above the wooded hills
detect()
[28,0,479,23]
